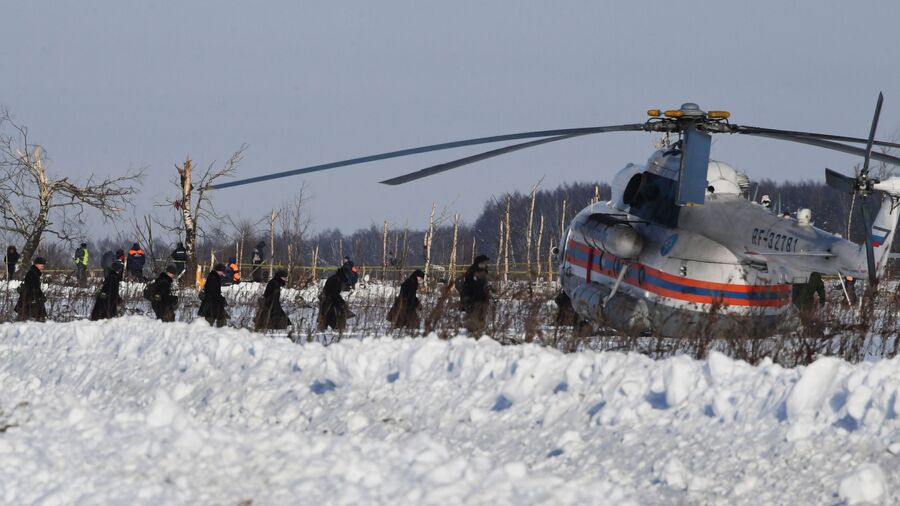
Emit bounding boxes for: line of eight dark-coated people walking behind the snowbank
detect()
[15,256,491,332]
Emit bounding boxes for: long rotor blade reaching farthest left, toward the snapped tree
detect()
[210,123,646,190]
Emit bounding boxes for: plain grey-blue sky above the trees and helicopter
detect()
[0,0,900,240]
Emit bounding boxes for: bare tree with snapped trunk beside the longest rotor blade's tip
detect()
[162,144,248,278]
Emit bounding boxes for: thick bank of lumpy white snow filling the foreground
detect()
[0,317,900,506]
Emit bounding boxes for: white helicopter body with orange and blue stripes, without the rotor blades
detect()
[559,152,898,336]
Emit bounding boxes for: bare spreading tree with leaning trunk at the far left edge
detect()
[0,110,142,272]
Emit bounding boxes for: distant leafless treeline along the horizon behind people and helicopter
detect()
[15,179,879,278]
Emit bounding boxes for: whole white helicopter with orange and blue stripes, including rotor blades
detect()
[212,93,900,336]
